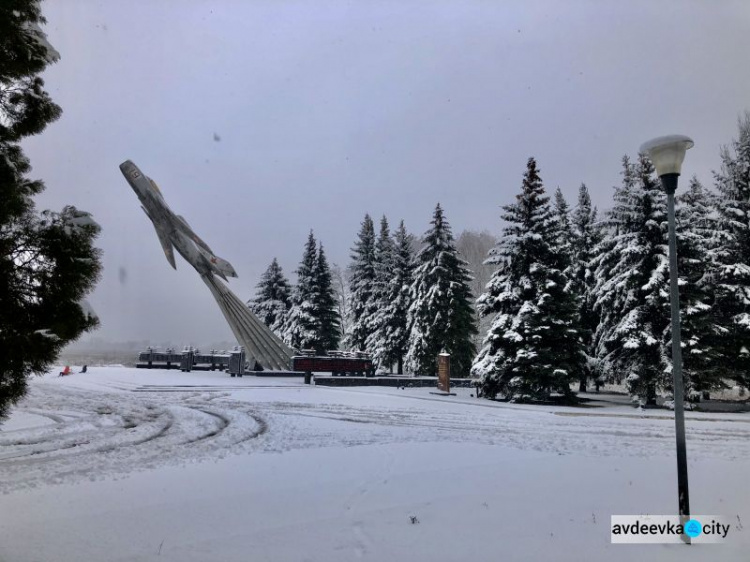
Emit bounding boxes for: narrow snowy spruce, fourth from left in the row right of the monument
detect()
[346,215,375,351]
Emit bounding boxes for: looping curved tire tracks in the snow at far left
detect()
[0,385,268,491]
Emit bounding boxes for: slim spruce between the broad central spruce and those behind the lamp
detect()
[568,184,602,392]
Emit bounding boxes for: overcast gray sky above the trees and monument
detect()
[25,0,750,343]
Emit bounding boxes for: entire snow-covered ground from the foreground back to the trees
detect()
[0,367,750,562]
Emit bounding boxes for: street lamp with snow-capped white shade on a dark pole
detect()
[641,135,693,525]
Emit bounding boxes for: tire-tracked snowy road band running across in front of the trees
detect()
[0,374,750,491]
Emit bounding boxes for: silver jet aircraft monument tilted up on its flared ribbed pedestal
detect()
[120,160,293,371]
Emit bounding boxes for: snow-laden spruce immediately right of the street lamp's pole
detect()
[676,177,726,397]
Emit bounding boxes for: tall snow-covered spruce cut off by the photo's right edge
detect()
[712,113,750,388]
